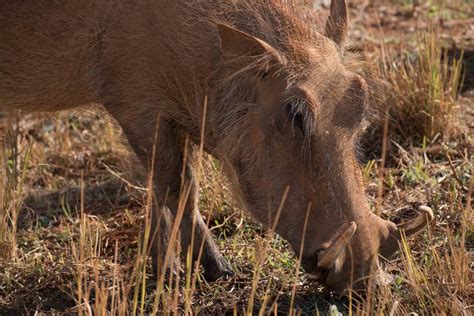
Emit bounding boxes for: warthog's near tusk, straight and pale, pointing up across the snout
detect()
[318,222,357,270]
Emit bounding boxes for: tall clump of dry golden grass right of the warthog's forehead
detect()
[369,30,463,143]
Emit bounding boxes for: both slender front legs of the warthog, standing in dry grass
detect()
[110,111,232,280]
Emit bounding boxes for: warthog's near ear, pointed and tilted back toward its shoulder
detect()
[217,24,278,57]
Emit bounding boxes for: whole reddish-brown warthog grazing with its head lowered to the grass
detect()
[0,0,433,291]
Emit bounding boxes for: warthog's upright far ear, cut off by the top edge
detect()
[325,0,348,47]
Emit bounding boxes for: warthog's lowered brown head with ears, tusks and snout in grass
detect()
[213,0,432,292]
